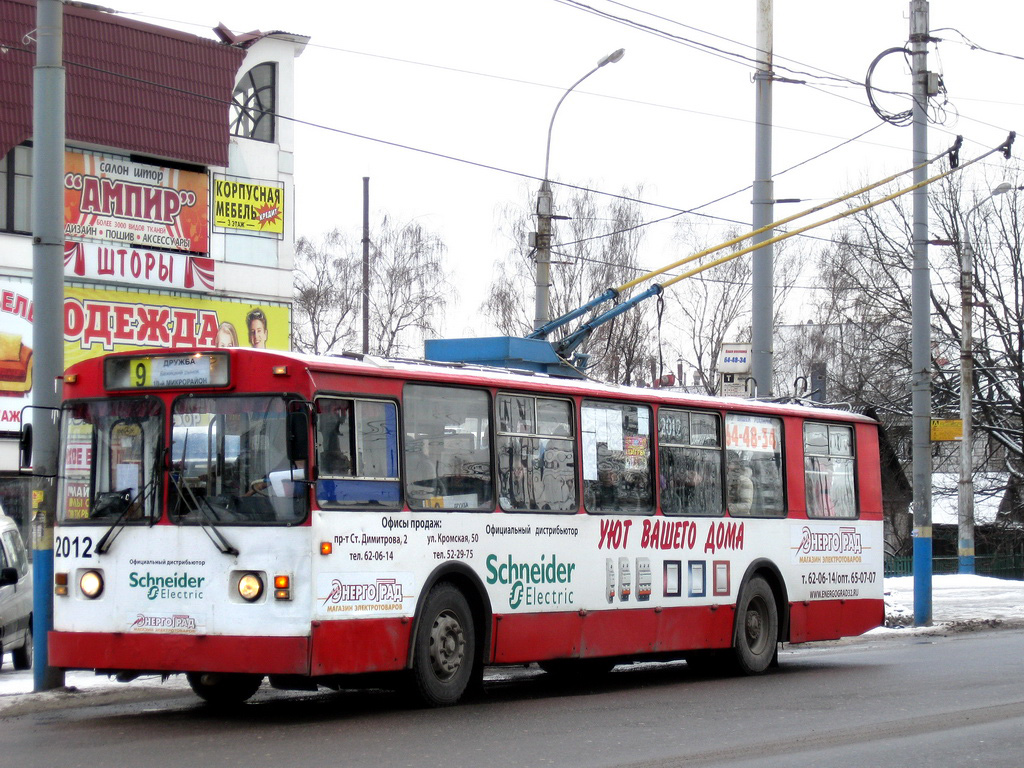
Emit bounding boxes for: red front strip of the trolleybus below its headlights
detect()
[49,632,309,675]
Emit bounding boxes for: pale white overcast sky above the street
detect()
[110,0,1024,336]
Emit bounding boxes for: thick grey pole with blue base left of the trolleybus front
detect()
[31,0,65,691]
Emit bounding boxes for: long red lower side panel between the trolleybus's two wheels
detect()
[493,605,735,664]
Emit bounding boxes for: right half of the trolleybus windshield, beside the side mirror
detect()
[168,395,308,525]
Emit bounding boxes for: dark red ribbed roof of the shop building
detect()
[0,0,245,166]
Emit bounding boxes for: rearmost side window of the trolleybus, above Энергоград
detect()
[804,423,857,518]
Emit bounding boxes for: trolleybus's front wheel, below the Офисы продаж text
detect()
[413,582,482,707]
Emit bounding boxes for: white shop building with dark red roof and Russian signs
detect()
[0,0,308,536]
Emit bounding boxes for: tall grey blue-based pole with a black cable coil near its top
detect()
[910,0,932,627]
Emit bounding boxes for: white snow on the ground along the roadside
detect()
[0,574,1024,715]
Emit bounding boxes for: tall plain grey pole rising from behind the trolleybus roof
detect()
[751,0,775,396]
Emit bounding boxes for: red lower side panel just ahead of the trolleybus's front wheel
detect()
[311,618,413,675]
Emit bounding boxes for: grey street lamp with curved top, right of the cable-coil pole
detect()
[956,181,1013,573]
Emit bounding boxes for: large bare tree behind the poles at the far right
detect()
[786,169,1024,551]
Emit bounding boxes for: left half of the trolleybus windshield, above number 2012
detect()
[59,397,163,525]
